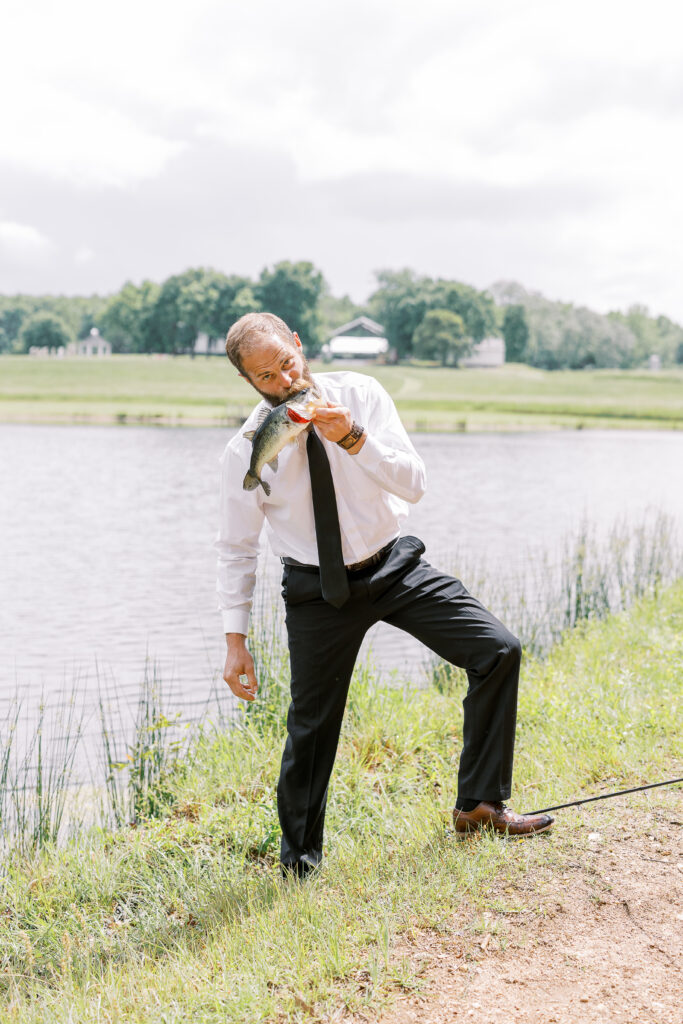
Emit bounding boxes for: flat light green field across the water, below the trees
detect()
[0,355,683,431]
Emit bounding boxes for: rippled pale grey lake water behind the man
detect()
[0,426,683,774]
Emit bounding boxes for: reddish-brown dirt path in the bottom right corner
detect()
[366,794,683,1024]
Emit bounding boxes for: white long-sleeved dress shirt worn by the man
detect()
[215,372,425,634]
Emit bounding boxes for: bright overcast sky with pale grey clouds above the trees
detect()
[0,0,683,321]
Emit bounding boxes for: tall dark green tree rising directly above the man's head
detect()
[254,260,326,353]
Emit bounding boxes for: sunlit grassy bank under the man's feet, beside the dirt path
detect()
[0,584,683,1024]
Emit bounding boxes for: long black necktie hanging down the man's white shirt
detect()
[306,429,350,608]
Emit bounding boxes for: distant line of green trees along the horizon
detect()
[0,261,683,370]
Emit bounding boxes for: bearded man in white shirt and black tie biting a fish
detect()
[216,313,553,876]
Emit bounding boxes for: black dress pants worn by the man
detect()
[278,537,521,867]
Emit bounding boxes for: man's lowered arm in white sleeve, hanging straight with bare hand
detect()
[215,446,264,700]
